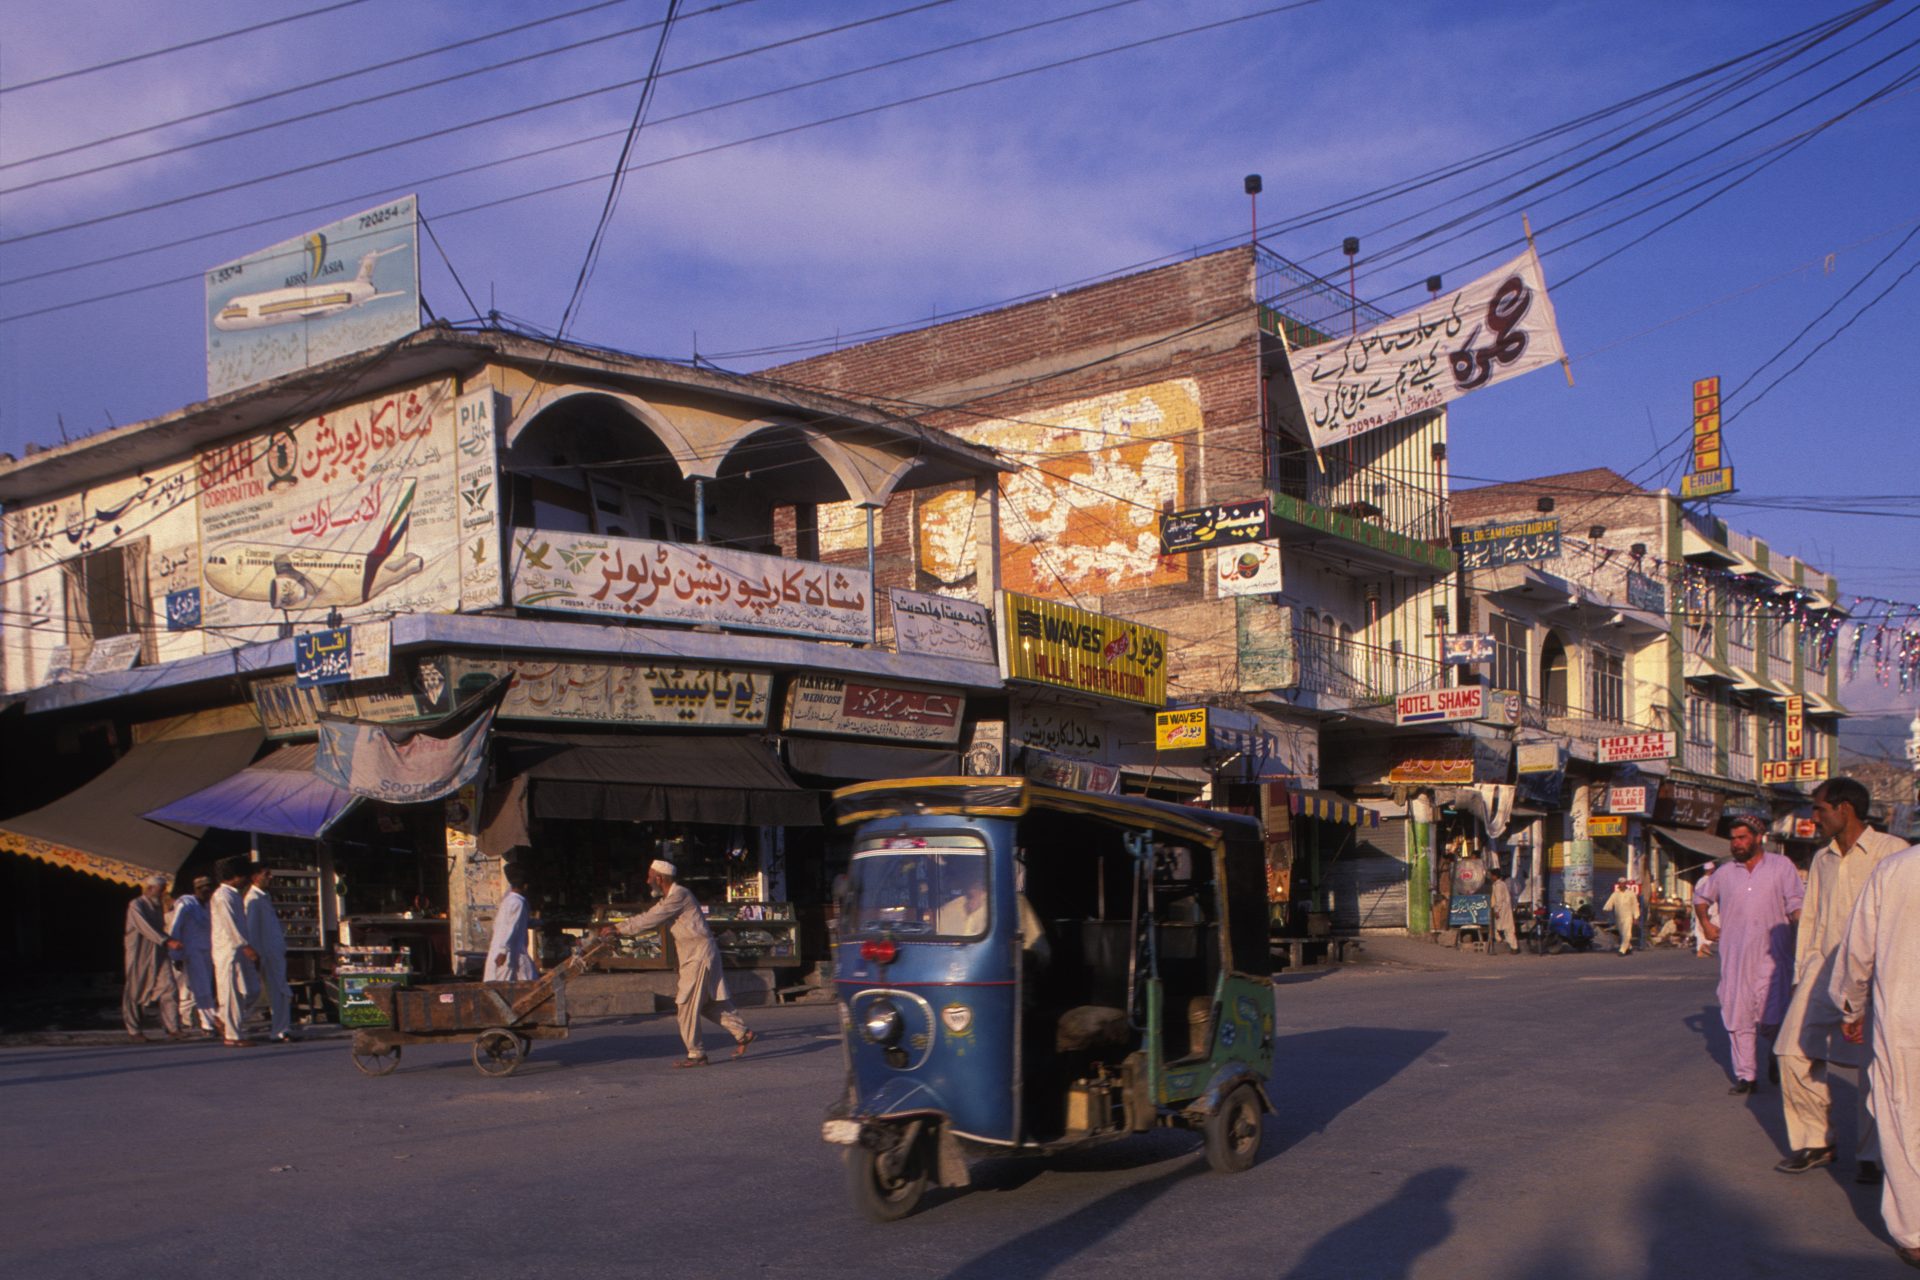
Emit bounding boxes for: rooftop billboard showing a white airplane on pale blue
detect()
[207,196,420,399]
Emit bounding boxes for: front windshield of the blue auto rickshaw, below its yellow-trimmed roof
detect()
[847,835,989,938]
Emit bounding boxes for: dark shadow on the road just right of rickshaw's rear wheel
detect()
[1265,1027,1446,1157]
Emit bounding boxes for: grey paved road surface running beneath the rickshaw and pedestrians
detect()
[0,946,1905,1280]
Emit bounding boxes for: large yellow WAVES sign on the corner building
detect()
[1000,591,1167,708]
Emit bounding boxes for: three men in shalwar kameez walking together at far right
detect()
[1693,777,1920,1267]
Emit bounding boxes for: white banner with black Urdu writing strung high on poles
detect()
[1288,248,1567,449]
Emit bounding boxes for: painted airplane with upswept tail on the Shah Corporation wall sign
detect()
[205,480,426,608]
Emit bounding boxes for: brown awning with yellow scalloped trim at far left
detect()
[0,729,263,885]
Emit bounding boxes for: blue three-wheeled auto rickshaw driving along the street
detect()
[822,777,1273,1221]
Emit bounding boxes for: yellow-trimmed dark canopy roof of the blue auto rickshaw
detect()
[833,777,1260,846]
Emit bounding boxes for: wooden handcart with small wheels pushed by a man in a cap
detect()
[353,938,607,1077]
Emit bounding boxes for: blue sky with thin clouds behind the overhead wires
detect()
[0,0,1920,706]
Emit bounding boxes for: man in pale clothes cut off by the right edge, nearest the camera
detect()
[1828,846,1920,1267]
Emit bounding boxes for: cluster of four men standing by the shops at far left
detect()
[121,858,294,1048]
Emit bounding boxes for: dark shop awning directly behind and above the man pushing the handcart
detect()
[493,733,820,827]
